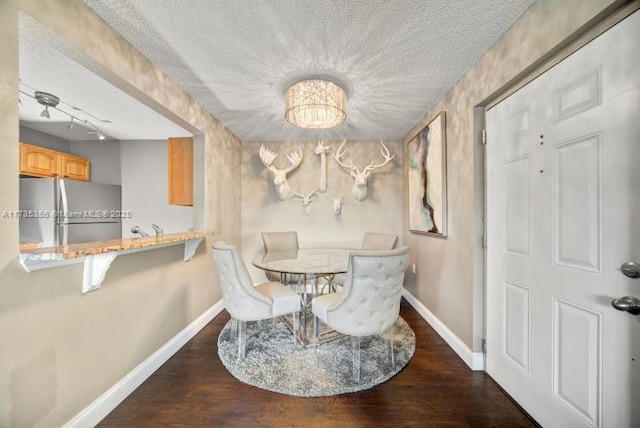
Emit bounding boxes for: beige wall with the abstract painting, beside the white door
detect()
[404,0,623,352]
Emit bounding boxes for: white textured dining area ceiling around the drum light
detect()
[80,0,533,141]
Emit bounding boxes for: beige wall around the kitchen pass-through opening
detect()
[0,0,240,427]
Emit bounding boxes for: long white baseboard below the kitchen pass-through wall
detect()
[64,300,224,428]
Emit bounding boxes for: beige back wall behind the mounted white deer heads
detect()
[242,141,404,281]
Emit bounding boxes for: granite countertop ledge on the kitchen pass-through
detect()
[20,232,216,260]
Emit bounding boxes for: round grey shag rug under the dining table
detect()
[218,317,416,397]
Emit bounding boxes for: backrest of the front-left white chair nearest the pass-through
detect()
[212,241,271,321]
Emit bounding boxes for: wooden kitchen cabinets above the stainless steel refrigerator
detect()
[20,143,90,181]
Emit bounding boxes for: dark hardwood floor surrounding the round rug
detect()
[98,300,535,428]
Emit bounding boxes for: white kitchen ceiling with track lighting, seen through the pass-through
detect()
[19,14,192,141]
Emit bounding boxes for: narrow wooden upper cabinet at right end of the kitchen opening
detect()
[169,137,193,206]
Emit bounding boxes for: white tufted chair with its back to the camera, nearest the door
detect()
[311,247,409,382]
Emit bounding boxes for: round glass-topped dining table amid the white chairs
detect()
[253,248,353,346]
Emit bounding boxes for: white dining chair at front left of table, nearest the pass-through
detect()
[212,241,300,360]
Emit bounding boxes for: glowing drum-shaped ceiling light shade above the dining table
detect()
[284,79,347,129]
